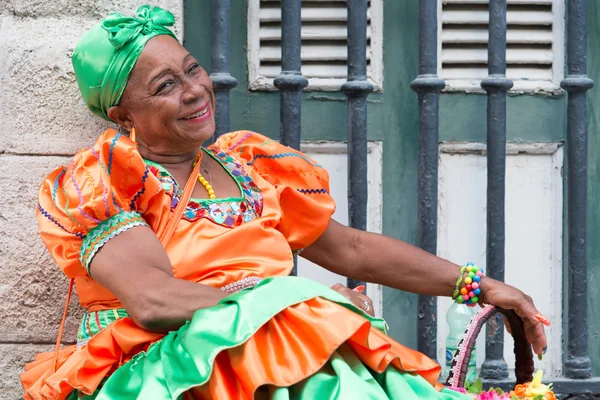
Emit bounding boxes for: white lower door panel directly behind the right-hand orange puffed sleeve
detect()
[298,142,383,317]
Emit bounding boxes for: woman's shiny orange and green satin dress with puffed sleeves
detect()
[21,130,458,400]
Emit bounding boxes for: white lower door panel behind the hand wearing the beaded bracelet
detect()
[438,144,563,377]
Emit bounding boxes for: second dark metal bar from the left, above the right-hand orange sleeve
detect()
[273,0,308,276]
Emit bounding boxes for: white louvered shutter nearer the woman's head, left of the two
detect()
[249,0,382,90]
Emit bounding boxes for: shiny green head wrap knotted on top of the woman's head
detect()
[72,6,177,121]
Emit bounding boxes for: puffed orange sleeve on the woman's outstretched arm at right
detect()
[216,131,335,250]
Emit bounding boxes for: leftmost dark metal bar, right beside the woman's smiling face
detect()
[210,0,237,141]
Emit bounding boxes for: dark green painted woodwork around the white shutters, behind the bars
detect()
[185,0,600,375]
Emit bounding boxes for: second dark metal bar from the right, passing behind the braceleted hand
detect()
[481,0,513,379]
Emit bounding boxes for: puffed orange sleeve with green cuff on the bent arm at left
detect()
[37,130,162,278]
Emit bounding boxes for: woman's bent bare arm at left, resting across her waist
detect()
[90,226,227,332]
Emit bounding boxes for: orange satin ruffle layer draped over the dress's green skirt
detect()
[21,297,441,400]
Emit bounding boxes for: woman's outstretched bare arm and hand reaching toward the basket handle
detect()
[302,220,547,354]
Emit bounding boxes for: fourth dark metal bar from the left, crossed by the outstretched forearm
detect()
[410,0,444,360]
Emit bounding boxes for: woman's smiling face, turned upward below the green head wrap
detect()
[109,35,215,156]
